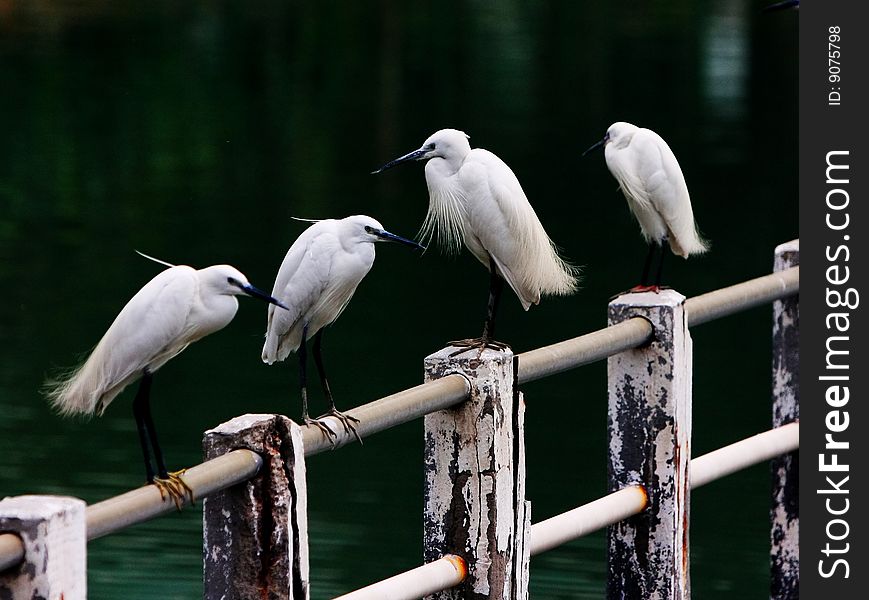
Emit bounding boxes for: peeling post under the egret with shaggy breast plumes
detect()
[424,348,531,600]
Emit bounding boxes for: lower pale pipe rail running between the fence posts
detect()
[335,422,800,600]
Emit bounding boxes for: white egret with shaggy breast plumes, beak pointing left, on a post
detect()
[374,129,578,351]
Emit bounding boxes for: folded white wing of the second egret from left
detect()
[262,227,340,364]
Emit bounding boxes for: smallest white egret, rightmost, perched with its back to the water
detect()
[582,122,708,292]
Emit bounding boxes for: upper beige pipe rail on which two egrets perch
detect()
[0,267,799,571]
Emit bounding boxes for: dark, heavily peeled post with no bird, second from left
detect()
[202,414,309,600]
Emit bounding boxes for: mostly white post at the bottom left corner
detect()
[0,496,87,600]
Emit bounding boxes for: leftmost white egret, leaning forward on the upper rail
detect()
[45,257,280,508]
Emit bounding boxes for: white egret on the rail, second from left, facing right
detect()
[262,215,425,442]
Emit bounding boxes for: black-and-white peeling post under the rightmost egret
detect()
[607,290,692,599]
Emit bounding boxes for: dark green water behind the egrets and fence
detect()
[0,0,798,599]
